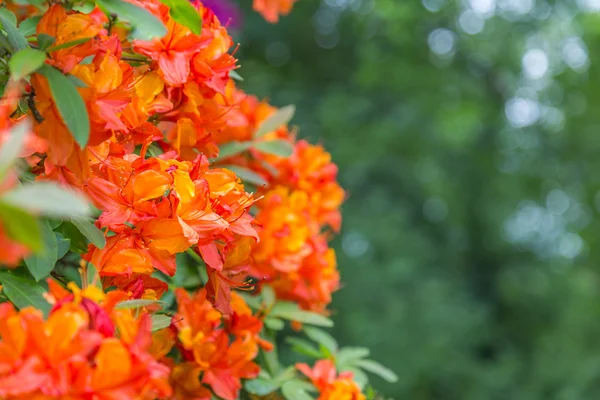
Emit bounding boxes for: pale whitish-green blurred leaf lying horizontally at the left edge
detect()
[0,182,90,218]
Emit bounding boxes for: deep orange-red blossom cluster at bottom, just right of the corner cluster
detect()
[171,289,270,400]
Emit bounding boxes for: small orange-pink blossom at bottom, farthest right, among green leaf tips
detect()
[296,360,366,400]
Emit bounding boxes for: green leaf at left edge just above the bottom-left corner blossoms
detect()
[0,271,50,315]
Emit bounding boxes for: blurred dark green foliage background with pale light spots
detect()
[236,0,600,400]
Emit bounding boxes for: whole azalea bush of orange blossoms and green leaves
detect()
[0,0,396,400]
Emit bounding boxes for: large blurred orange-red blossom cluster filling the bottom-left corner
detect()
[0,288,171,400]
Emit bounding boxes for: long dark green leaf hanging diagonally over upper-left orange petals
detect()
[39,65,90,148]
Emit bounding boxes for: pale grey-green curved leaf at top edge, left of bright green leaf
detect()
[96,0,168,40]
